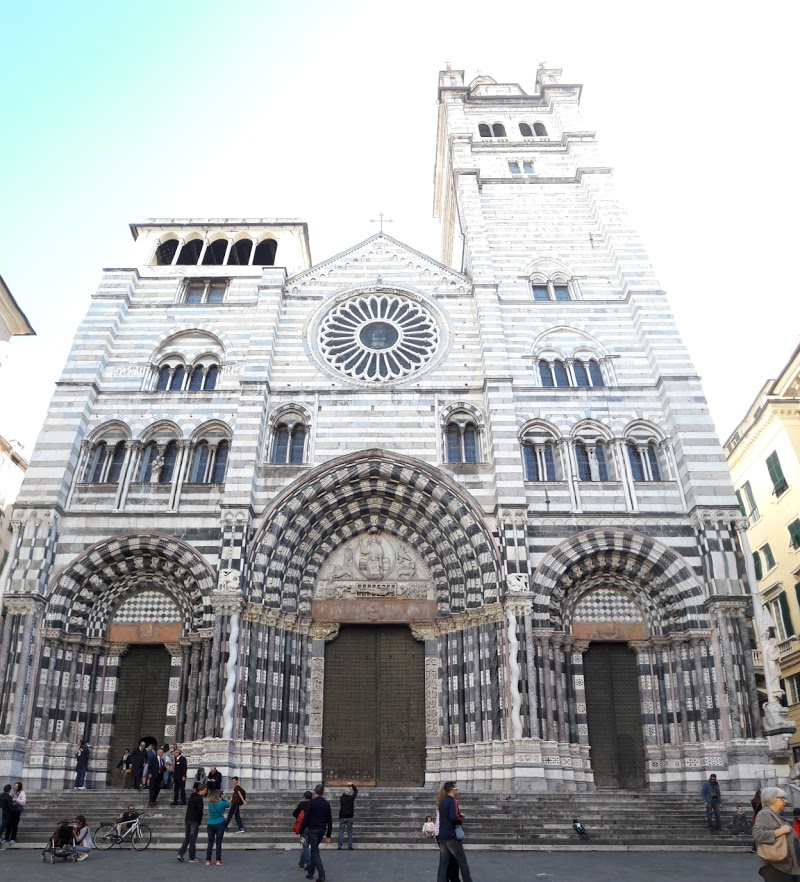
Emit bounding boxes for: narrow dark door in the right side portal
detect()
[584,643,646,790]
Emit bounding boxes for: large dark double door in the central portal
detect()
[322,625,425,787]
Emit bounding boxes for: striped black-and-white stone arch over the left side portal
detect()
[45,532,215,638]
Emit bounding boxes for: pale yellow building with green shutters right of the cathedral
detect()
[725,346,800,760]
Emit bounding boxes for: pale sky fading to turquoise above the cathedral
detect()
[0,0,800,453]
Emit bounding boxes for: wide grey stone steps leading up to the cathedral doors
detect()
[9,788,752,851]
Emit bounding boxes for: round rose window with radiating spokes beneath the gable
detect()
[319,294,439,381]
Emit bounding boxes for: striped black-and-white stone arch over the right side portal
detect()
[532,529,709,636]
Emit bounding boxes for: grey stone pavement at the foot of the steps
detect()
[0,847,761,882]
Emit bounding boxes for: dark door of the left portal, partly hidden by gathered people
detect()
[109,644,172,780]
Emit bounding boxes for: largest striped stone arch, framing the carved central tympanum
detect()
[249,449,500,615]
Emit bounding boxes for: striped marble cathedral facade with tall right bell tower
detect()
[0,69,768,790]
